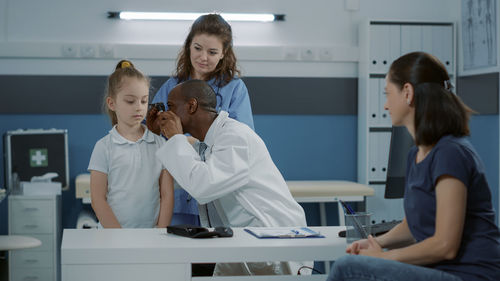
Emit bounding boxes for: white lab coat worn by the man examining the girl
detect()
[156,111,306,275]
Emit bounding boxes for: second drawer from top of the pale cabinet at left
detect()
[9,216,54,234]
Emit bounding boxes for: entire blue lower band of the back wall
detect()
[0,112,499,234]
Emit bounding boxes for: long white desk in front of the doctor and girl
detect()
[61,226,346,281]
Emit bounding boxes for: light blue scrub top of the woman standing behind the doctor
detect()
[152,77,255,215]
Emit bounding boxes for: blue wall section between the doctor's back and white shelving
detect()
[254,115,357,225]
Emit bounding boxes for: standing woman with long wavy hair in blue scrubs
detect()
[147,14,254,224]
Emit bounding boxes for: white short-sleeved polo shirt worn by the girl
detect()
[88,125,166,228]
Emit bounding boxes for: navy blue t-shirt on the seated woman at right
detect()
[404,136,500,281]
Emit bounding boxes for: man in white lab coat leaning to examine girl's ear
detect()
[155,80,306,275]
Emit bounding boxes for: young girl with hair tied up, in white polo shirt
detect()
[88,60,174,228]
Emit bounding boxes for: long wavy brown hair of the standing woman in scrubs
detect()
[175,14,241,87]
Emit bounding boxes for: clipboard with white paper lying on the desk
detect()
[245,227,324,238]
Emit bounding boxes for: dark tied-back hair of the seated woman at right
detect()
[388,52,473,145]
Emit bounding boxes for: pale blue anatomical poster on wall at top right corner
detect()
[461,0,498,71]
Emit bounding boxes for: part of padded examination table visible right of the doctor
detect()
[286,180,375,226]
